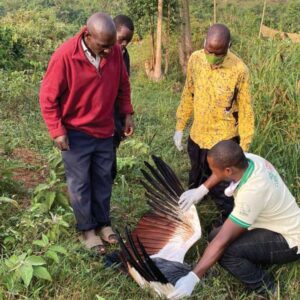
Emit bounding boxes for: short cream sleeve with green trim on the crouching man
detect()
[229,186,267,228]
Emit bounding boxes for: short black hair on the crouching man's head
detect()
[207,140,248,169]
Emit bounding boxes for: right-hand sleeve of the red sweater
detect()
[117,49,133,115]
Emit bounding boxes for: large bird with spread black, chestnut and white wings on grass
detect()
[117,156,201,296]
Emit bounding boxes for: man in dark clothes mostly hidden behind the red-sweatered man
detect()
[111,15,134,180]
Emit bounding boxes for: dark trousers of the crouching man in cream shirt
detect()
[209,227,300,294]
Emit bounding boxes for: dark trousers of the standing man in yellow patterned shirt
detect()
[188,137,239,223]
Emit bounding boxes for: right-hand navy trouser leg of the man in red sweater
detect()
[91,138,114,226]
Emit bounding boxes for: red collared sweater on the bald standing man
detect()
[40,28,133,138]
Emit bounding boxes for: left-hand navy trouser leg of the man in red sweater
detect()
[62,131,97,231]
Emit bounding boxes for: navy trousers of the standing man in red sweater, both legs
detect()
[62,130,113,231]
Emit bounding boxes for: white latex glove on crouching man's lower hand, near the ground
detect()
[168,271,200,300]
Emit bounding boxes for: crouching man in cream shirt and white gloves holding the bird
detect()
[169,141,300,299]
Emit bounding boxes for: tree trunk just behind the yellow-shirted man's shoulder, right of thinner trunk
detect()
[179,0,192,74]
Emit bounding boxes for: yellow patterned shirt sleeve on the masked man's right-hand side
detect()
[237,68,254,151]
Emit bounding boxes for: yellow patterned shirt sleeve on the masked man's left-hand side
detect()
[176,55,194,131]
